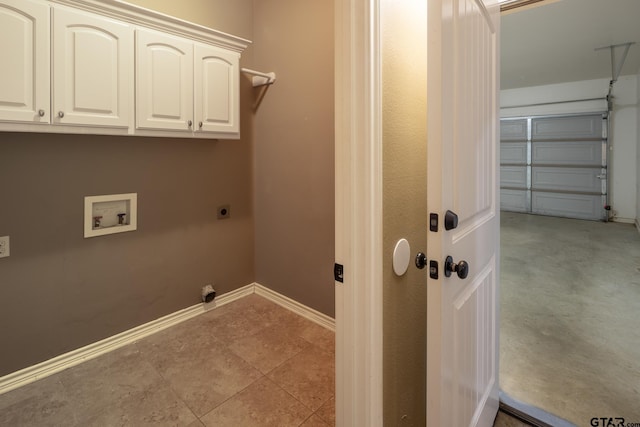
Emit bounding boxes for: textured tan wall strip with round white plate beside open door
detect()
[381,0,428,426]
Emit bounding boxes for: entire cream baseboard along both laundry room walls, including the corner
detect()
[0,283,335,394]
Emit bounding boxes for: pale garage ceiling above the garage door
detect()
[500,0,640,89]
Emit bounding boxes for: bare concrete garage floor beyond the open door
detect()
[500,212,640,426]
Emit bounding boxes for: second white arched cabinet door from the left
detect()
[53,8,133,127]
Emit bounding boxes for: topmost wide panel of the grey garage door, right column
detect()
[531,114,602,141]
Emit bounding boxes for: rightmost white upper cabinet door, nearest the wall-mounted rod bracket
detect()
[194,44,240,133]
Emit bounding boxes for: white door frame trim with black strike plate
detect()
[334,0,383,427]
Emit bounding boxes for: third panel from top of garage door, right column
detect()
[531,167,602,194]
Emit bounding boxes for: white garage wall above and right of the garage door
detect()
[500,75,640,222]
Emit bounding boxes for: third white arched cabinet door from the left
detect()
[136,29,193,131]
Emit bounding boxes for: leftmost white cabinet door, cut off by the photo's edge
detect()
[0,0,51,123]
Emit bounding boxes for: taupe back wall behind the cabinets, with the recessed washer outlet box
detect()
[0,0,255,376]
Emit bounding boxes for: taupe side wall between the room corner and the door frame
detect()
[253,0,335,316]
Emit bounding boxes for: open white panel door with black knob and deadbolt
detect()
[427,0,500,427]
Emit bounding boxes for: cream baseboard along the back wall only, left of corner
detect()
[0,284,255,394]
